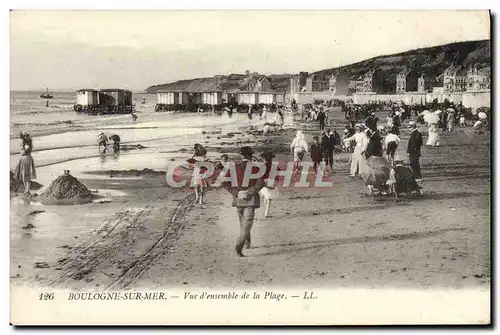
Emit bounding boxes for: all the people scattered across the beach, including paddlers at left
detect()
[9,96,488,256]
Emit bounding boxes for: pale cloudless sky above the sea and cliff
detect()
[10,10,490,91]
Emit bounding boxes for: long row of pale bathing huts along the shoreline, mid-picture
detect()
[155,91,285,112]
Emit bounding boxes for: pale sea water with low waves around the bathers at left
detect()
[10,92,261,187]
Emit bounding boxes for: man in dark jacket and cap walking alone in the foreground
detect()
[222,147,265,257]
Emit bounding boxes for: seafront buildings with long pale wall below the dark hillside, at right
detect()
[288,62,491,108]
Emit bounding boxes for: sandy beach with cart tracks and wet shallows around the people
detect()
[10,109,490,290]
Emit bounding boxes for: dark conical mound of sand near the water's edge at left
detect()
[39,173,95,203]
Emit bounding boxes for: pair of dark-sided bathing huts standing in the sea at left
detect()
[73,89,134,114]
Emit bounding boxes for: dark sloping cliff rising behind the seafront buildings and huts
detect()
[146,40,491,93]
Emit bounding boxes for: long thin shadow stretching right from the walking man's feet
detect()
[252,228,467,257]
